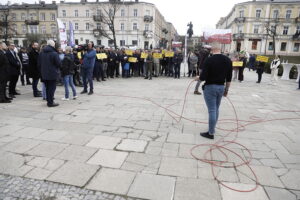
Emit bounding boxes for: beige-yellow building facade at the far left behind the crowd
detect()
[0,1,57,46]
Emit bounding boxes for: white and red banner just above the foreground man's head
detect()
[203,29,232,44]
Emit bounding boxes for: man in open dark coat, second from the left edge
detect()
[6,43,21,98]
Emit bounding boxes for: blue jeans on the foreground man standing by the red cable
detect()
[203,85,224,135]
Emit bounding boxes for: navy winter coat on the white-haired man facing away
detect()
[38,46,61,80]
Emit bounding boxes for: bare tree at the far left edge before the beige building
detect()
[0,5,17,43]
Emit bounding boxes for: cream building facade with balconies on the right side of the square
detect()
[217,0,300,56]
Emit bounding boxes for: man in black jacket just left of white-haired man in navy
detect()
[28,42,42,97]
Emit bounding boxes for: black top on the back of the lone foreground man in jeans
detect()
[200,54,232,85]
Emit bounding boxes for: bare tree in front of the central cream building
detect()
[94,0,122,48]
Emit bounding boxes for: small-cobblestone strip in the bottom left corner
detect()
[0,175,143,200]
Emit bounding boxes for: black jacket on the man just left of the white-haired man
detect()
[27,48,41,79]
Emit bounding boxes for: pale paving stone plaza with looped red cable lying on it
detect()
[0,70,300,200]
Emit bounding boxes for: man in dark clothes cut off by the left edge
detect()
[0,43,12,103]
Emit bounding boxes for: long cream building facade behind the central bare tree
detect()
[58,0,177,49]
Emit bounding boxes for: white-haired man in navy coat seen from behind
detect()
[38,40,61,107]
